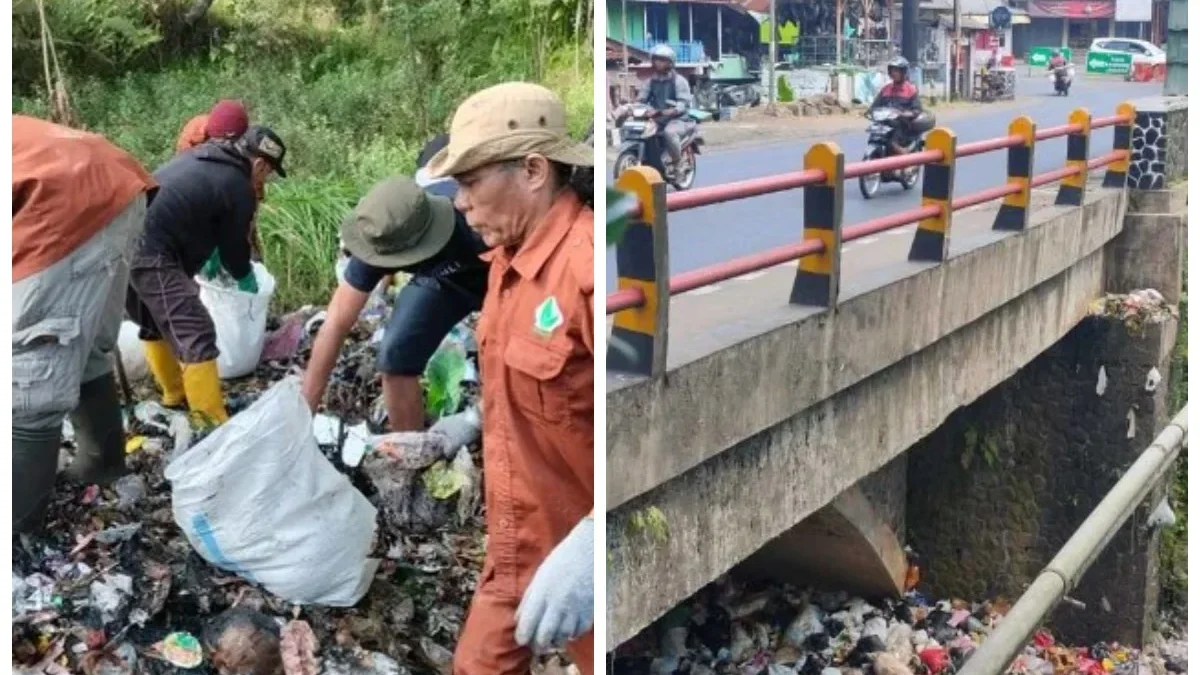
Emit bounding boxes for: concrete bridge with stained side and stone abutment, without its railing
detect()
[606,93,1187,650]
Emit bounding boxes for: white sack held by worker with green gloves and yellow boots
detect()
[196,263,275,380]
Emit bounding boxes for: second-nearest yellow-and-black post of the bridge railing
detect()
[791,143,846,307]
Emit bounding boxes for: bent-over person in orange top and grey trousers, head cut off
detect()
[12,115,157,532]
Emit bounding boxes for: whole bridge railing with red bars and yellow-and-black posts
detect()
[606,102,1135,376]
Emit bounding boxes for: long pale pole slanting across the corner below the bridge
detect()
[959,405,1188,675]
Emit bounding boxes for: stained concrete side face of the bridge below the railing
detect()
[606,182,1124,650]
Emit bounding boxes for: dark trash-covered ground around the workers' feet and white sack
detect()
[12,283,520,675]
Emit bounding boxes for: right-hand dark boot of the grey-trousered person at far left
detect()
[66,372,125,485]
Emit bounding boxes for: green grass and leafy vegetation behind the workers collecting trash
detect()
[12,0,593,310]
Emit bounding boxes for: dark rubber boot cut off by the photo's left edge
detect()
[12,424,62,533]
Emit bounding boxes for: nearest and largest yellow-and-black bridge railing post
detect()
[608,167,671,376]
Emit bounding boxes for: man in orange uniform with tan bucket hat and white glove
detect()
[428,83,595,675]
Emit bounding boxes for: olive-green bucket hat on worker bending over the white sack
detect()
[342,175,455,268]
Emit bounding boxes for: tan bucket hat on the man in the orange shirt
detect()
[428,82,594,178]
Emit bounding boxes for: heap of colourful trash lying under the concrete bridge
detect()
[610,578,1164,675]
